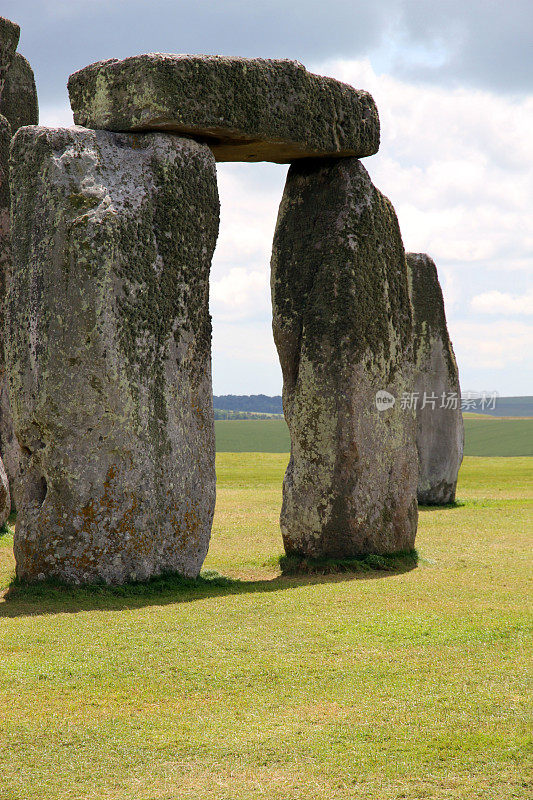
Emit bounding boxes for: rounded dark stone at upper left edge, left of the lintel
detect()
[0,53,39,135]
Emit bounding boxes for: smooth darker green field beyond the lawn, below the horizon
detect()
[215,414,533,456]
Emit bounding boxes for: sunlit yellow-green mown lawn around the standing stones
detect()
[0,456,533,800]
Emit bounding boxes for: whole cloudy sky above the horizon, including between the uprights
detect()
[5,0,533,395]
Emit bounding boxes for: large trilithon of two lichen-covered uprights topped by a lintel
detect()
[0,21,458,583]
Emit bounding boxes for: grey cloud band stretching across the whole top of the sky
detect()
[2,0,533,104]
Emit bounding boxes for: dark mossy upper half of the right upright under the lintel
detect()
[272,159,412,377]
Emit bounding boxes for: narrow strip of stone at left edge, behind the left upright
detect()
[0,114,20,507]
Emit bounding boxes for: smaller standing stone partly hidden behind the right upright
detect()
[407,253,464,505]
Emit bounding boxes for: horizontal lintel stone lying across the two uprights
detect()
[68,53,379,163]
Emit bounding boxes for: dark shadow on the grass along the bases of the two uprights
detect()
[0,550,418,618]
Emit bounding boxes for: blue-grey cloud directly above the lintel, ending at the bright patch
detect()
[2,0,387,103]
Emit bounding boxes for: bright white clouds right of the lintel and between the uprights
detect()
[212,61,533,394]
